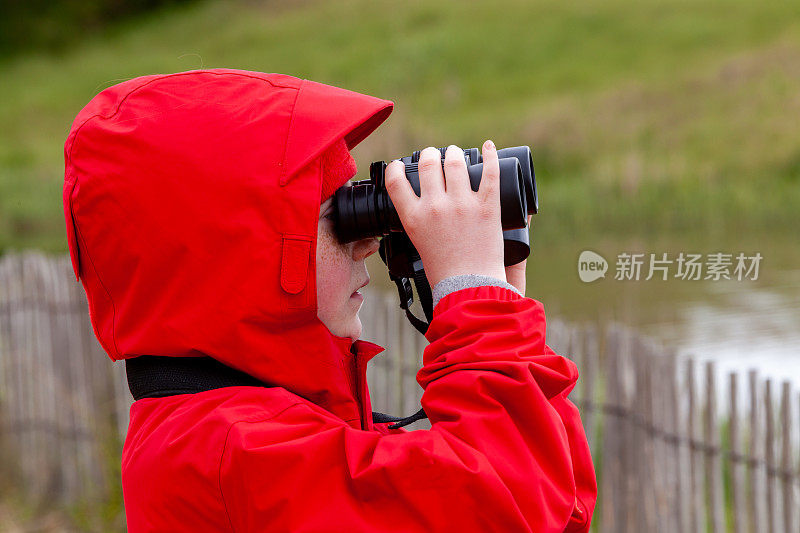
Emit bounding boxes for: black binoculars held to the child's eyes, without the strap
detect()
[333,146,539,265]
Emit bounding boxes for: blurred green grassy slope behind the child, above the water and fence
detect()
[0,0,800,251]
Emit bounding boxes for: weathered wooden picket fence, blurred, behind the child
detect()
[0,253,800,533]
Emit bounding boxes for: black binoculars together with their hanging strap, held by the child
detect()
[333,146,539,334]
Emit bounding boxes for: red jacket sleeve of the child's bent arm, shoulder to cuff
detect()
[220,287,596,532]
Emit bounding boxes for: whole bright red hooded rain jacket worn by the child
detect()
[64,70,596,533]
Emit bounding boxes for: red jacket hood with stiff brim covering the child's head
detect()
[63,69,393,426]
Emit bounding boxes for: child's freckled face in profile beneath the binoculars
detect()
[317,190,378,341]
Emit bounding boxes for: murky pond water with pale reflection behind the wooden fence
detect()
[529,237,800,388]
